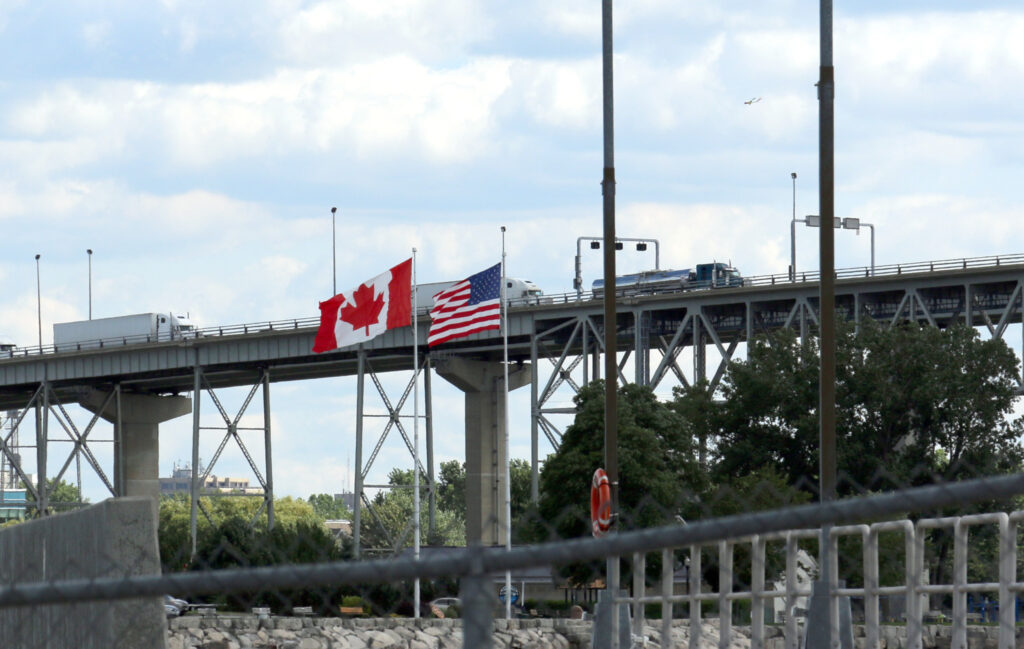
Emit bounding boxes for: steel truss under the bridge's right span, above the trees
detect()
[530,272,1024,497]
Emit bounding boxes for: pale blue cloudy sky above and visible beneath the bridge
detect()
[0,0,1024,497]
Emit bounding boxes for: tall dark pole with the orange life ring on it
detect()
[601,0,618,649]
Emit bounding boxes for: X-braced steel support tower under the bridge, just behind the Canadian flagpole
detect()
[352,349,437,559]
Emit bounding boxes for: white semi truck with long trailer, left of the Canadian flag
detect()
[53,313,197,351]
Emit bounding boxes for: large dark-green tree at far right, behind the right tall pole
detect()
[674,318,1024,582]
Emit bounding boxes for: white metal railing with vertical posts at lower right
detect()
[617,511,1024,649]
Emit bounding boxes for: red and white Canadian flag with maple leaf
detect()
[313,254,413,354]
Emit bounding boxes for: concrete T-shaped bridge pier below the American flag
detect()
[435,357,531,546]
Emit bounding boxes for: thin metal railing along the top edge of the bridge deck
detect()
[0,254,1024,359]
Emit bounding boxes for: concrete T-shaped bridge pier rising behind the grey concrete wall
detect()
[80,391,191,503]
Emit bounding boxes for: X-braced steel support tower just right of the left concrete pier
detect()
[189,363,274,555]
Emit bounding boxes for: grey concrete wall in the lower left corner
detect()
[0,497,167,649]
